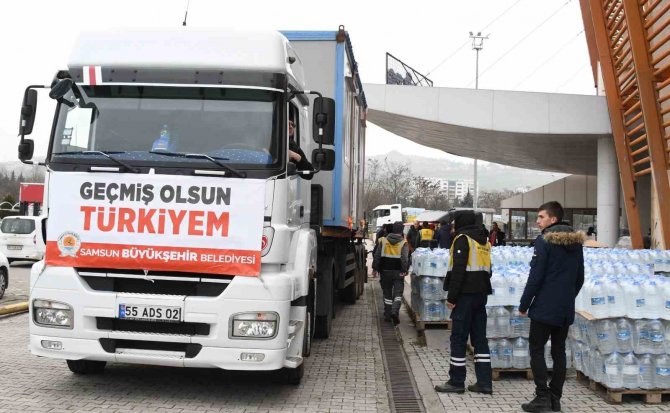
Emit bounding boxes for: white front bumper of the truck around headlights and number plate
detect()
[30,267,305,370]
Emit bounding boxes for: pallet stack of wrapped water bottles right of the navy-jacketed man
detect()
[570,249,670,389]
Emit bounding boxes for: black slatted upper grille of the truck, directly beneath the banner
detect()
[77,268,234,297]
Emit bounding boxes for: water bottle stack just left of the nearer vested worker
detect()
[411,248,451,321]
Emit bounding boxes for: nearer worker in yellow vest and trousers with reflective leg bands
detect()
[435,210,493,394]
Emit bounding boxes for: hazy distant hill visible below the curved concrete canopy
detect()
[368,151,567,191]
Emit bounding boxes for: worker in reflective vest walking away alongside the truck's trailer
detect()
[372,221,409,324]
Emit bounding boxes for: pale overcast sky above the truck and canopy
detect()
[0,0,595,161]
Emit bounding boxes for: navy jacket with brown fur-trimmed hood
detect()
[519,222,584,326]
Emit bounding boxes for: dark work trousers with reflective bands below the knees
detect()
[449,293,493,388]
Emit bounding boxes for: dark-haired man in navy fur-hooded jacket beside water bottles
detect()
[519,201,585,412]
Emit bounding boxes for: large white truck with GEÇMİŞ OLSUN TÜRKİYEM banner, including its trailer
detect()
[19,27,367,383]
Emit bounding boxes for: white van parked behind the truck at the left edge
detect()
[0,216,46,263]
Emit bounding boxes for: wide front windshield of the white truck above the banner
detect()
[50,85,281,169]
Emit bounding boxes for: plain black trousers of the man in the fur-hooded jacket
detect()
[528,320,569,398]
